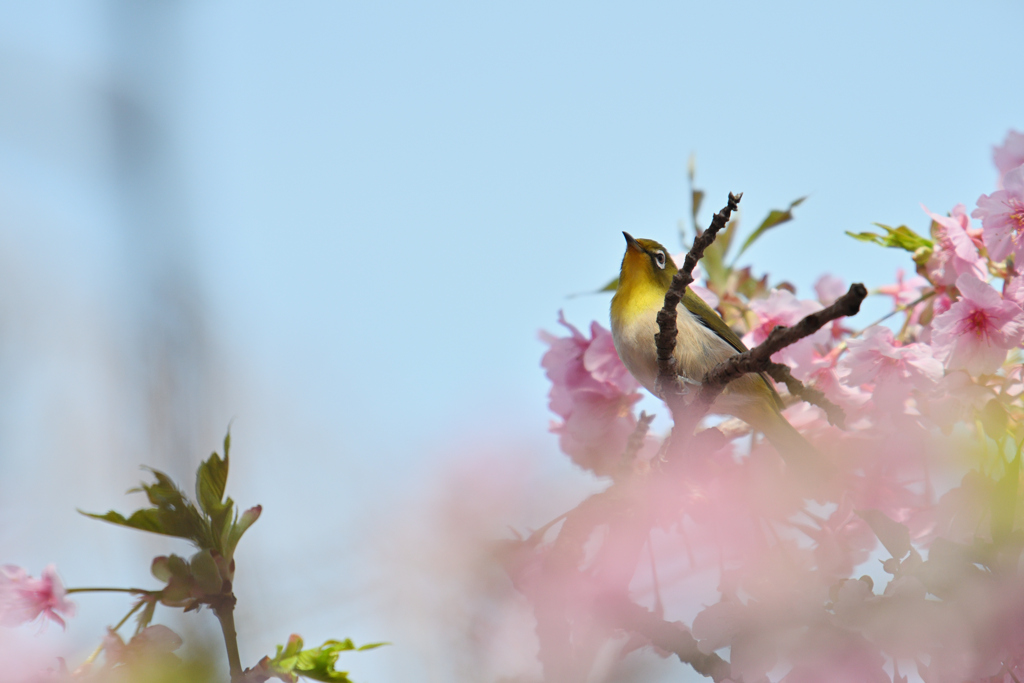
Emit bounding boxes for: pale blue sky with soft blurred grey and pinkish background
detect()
[0,0,1024,683]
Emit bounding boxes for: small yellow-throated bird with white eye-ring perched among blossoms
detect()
[611,232,819,463]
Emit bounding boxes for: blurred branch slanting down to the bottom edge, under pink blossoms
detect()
[605,599,731,683]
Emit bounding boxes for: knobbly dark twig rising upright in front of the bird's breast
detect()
[654,193,743,397]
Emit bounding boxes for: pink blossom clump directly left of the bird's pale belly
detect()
[541,313,640,474]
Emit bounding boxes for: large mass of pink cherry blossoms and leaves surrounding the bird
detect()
[532,131,1024,683]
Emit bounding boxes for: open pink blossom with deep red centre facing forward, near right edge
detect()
[932,273,1024,375]
